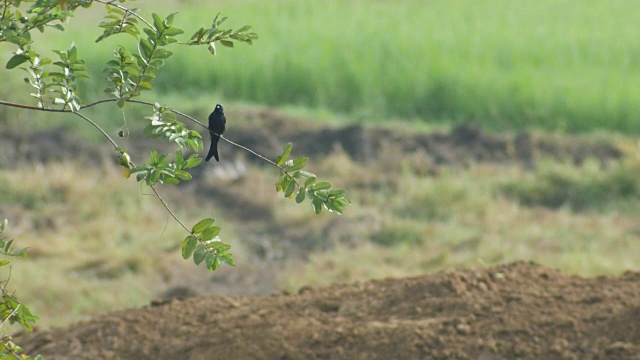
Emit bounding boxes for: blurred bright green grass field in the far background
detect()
[6,0,640,133]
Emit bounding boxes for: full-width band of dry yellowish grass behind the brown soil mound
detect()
[0,131,640,326]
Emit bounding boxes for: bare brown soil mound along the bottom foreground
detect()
[18,262,640,359]
